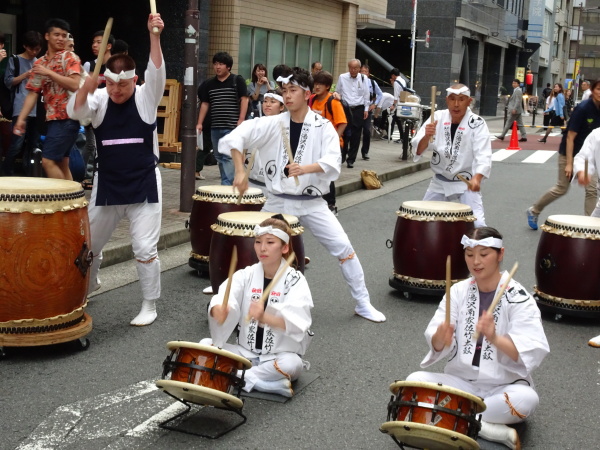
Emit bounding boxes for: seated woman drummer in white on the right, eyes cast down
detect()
[407,227,550,449]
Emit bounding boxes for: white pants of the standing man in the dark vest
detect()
[88,174,162,300]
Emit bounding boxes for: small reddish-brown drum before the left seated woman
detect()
[156,341,252,409]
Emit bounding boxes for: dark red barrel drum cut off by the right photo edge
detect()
[534,215,600,317]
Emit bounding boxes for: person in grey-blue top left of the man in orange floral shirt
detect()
[0,31,42,175]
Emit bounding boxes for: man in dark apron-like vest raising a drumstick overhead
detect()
[68,14,166,326]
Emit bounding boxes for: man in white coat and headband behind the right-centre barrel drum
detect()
[412,84,492,227]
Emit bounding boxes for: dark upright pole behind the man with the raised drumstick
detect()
[179,0,200,212]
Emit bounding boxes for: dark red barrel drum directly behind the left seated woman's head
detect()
[209,211,304,293]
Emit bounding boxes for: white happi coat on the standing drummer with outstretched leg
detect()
[219,110,342,215]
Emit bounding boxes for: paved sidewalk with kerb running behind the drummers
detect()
[97,112,503,267]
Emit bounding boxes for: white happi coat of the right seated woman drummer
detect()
[421,271,550,386]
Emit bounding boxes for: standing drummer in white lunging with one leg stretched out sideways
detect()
[219,67,385,322]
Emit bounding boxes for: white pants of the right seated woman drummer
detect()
[406,371,540,424]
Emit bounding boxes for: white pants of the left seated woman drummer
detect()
[200,338,303,392]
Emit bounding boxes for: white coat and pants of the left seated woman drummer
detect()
[201,259,313,392]
